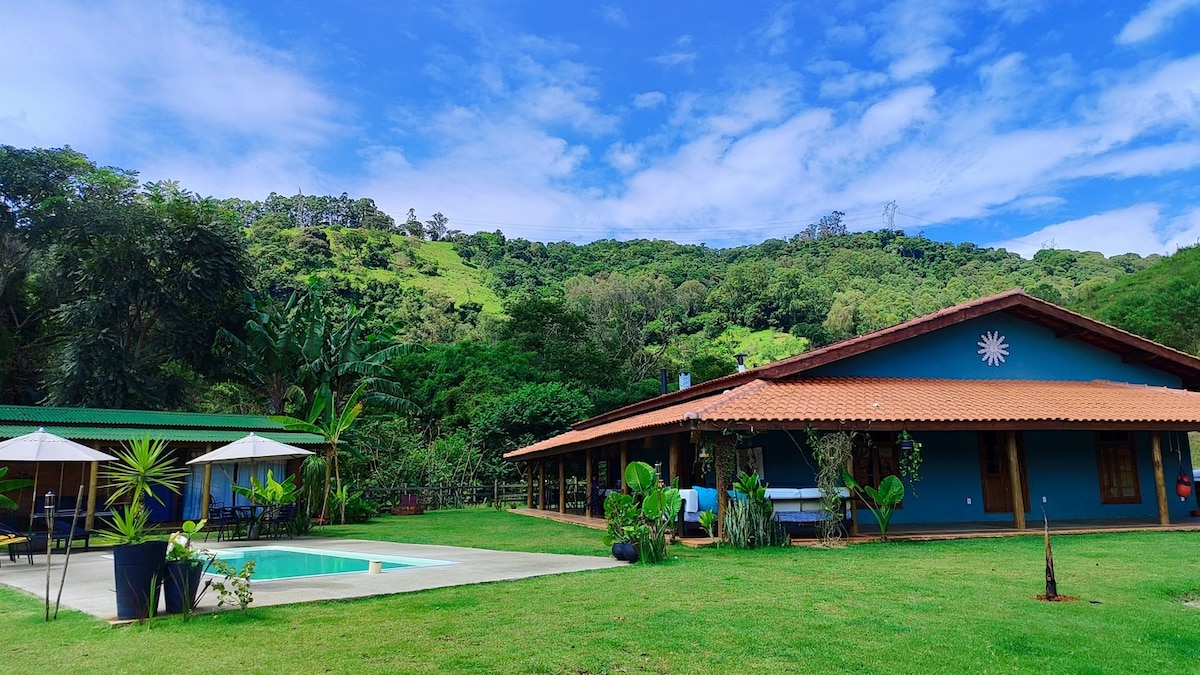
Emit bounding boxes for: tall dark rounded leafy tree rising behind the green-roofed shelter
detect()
[49,185,246,408]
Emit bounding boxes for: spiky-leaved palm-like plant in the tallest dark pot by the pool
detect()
[104,437,186,620]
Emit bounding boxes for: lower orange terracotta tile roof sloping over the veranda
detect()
[504,377,1200,459]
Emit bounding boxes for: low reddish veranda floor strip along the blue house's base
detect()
[512,507,1200,546]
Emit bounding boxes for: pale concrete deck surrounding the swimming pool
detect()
[0,538,629,620]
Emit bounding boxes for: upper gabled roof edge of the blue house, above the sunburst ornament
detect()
[575,288,1200,429]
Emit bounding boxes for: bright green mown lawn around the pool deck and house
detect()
[0,510,1200,673]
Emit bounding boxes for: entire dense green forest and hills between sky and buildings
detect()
[0,147,1200,486]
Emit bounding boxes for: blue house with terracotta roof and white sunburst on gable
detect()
[505,289,1200,531]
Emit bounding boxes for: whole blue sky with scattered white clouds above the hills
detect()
[0,0,1200,256]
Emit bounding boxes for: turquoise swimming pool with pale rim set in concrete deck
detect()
[209,545,454,581]
